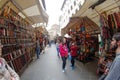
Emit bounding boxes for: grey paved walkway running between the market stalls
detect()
[21,45,98,80]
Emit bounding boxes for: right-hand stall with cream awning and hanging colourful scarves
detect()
[67,0,120,74]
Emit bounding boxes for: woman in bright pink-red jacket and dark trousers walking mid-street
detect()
[59,37,68,72]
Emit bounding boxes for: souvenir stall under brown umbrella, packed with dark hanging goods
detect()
[64,17,100,63]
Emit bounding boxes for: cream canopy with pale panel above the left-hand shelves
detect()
[1,0,48,25]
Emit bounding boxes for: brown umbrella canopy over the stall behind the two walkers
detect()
[62,16,100,34]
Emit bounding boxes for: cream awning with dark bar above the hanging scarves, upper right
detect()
[73,0,120,26]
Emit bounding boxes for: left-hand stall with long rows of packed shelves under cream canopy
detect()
[0,0,47,74]
